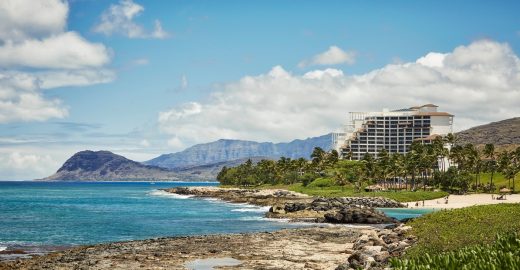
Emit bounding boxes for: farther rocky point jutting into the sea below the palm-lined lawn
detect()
[164,187,406,224]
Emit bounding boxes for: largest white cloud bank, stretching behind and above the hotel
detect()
[158,40,520,148]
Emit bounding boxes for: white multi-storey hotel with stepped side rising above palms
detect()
[333,104,453,160]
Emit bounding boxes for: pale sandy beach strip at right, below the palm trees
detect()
[408,194,520,209]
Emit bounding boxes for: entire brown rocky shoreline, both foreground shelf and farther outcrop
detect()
[0,187,415,270]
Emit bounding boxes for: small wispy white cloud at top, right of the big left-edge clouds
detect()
[93,0,168,39]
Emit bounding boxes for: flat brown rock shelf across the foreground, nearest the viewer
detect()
[0,225,413,270]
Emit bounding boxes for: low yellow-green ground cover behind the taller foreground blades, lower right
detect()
[407,204,520,257]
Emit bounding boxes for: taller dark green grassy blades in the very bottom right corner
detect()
[390,233,520,270]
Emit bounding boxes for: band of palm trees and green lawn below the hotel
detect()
[217,134,520,197]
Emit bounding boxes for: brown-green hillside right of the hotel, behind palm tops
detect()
[455,117,520,148]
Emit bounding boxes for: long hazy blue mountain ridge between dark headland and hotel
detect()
[143,134,332,169]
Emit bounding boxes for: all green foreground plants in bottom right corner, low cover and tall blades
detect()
[391,204,520,269]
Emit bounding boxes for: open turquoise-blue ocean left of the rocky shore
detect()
[0,181,299,253]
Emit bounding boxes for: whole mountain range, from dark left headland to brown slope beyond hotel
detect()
[43,117,520,181]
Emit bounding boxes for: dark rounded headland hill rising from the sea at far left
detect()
[41,150,188,181]
